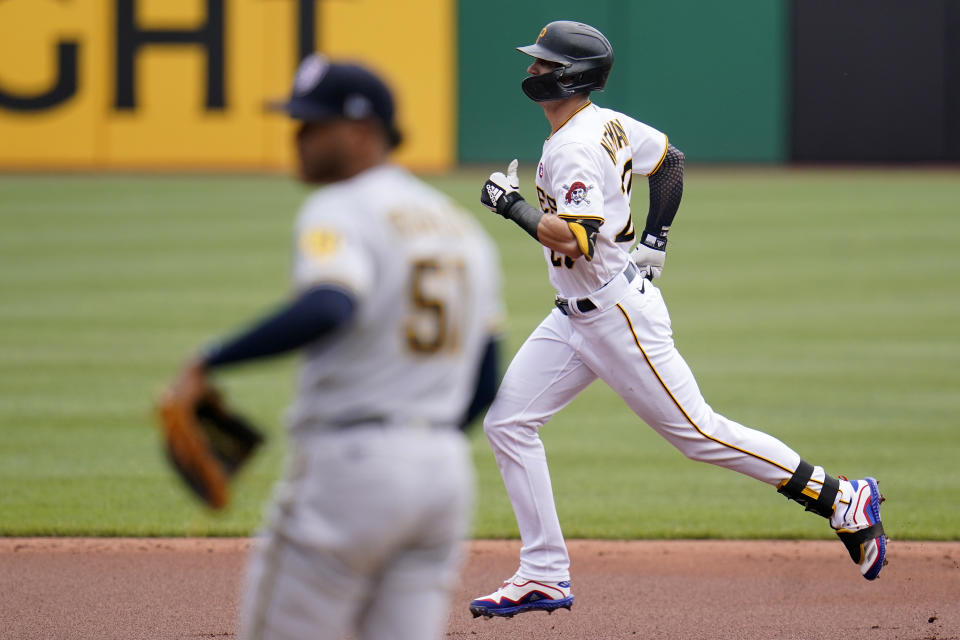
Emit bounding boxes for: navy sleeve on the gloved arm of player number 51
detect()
[203,287,355,368]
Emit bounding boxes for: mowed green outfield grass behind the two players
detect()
[0,167,960,540]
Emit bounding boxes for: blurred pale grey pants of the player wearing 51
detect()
[239,426,473,640]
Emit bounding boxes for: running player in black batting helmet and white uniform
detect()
[470,21,886,617]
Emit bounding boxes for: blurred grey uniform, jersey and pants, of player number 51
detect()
[241,165,503,640]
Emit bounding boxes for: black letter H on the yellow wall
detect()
[114,0,226,110]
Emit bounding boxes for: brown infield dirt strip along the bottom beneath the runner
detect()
[0,538,960,640]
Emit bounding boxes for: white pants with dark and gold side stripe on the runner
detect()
[484,278,824,581]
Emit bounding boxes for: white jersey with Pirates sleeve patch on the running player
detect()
[536,102,667,298]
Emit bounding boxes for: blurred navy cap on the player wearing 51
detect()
[269,53,401,148]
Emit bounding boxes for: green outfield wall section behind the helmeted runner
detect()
[457,0,790,164]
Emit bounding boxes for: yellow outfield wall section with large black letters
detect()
[0,0,457,170]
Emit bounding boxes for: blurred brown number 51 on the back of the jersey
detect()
[406,259,467,353]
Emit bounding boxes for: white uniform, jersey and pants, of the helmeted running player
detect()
[484,103,824,581]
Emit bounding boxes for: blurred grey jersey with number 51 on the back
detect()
[290,165,503,429]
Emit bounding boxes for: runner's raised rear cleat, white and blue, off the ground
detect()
[830,476,887,580]
